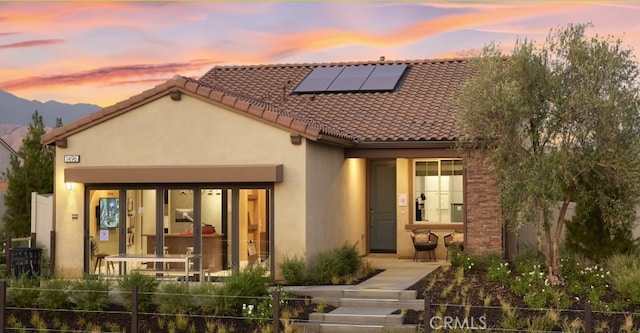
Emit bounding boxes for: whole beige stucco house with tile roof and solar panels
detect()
[41,59,504,277]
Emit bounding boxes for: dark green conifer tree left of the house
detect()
[3,110,56,237]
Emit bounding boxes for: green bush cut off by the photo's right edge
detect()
[606,254,640,304]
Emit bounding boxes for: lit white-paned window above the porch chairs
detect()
[413,159,464,223]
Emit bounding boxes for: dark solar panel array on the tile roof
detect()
[293,64,407,93]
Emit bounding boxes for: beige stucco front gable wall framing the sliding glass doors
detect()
[55,94,307,276]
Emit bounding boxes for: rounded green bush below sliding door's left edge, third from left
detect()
[69,277,109,311]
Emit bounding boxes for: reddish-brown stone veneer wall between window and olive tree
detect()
[464,152,503,254]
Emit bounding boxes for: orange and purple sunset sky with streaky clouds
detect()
[0,1,640,106]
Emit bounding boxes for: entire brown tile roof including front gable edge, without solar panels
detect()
[41,59,469,145]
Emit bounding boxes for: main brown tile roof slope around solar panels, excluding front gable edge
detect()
[200,59,469,142]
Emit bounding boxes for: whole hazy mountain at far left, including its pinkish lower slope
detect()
[0,90,101,151]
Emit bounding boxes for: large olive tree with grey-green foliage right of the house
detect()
[454,24,640,284]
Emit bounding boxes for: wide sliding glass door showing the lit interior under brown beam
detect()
[86,184,273,276]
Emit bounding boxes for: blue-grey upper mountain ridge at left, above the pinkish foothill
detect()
[0,90,101,127]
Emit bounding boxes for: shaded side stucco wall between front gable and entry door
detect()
[306,142,366,259]
